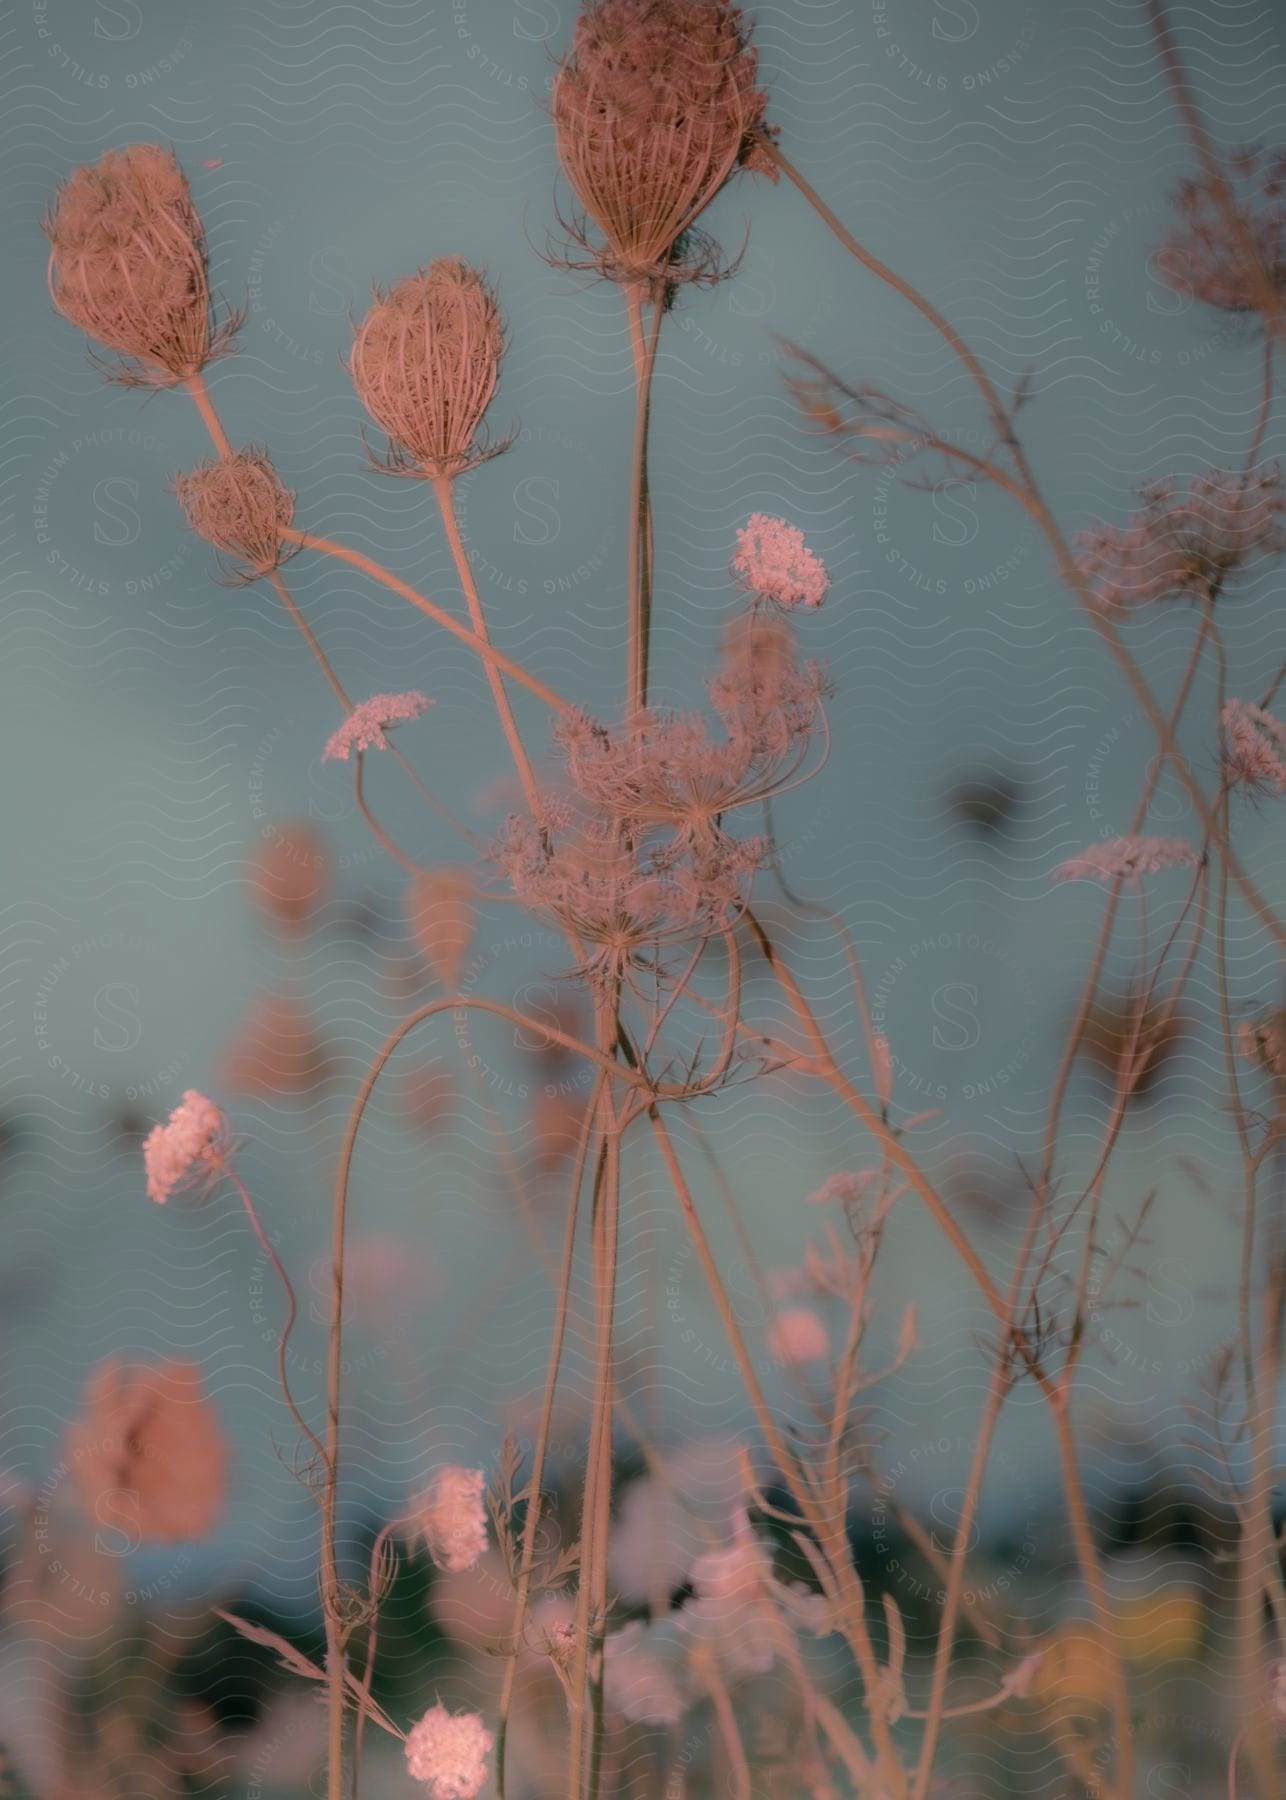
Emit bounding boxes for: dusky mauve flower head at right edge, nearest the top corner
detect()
[1156,144,1286,313]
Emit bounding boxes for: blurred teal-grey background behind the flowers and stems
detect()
[0,0,1286,1791]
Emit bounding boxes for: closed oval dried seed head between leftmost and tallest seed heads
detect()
[349,257,504,479]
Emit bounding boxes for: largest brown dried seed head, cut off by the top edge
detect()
[553,0,774,288]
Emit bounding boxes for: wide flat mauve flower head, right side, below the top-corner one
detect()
[1075,463,1286,612]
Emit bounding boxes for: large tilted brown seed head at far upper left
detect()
[43,144,241,387]
